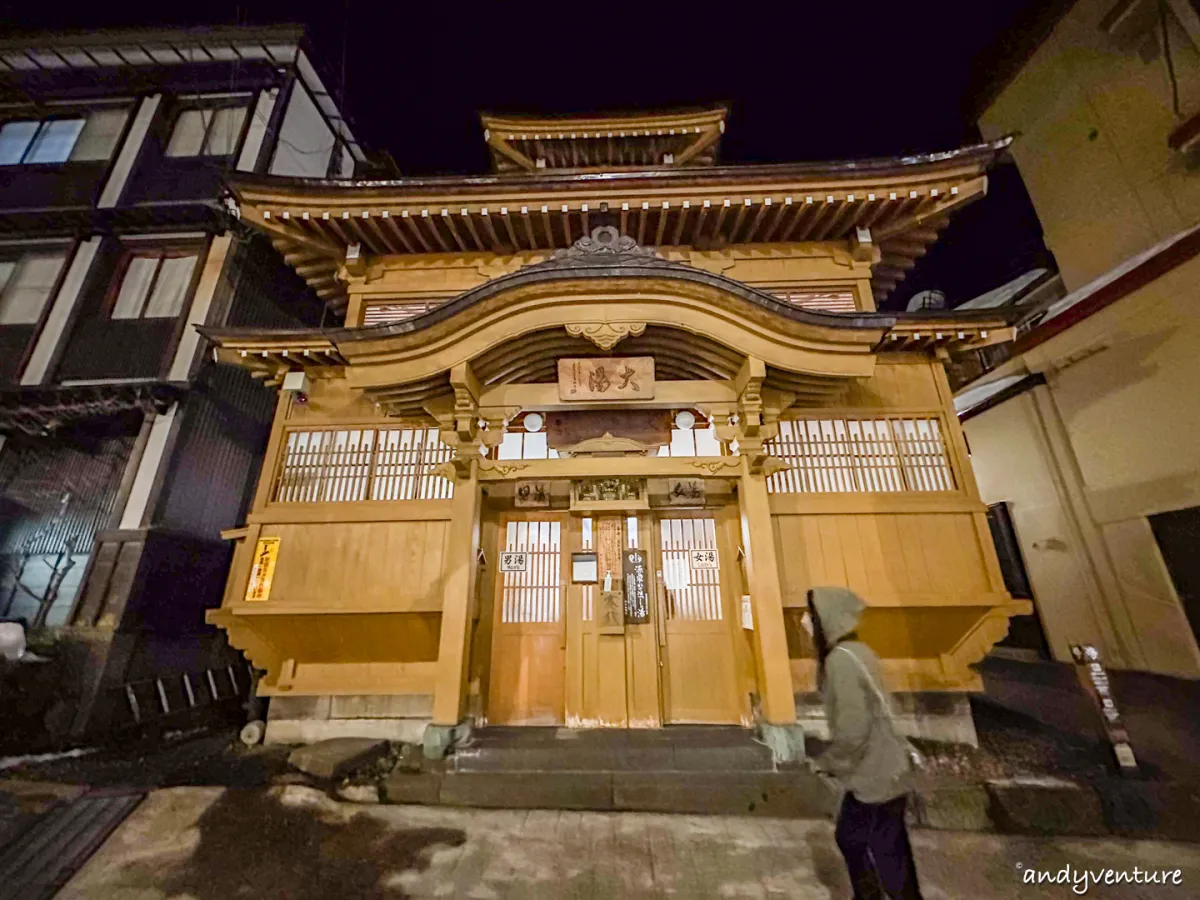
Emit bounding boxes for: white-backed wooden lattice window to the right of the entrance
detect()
[767,418,955,493]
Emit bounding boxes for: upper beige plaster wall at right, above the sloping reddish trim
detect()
[979,0,1200,290]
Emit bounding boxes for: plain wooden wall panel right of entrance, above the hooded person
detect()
[773,512,1003,607]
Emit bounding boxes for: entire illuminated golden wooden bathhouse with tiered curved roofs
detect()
[205,110,1024,739]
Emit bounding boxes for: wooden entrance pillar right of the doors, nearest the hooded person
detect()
[738,457,796,725]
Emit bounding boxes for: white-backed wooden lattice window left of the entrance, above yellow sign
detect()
[271,428,454,503]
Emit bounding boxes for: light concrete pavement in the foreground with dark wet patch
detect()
[59,785,1200,900]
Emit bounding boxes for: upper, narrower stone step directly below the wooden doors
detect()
[450,727,775,773]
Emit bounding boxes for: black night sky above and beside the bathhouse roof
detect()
[0,0,1046,306]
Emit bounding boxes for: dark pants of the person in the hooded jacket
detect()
[834,792,922,900]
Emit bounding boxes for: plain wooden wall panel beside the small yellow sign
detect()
[262,520,450,612]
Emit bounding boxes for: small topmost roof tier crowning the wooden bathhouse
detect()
[480,108,725,172]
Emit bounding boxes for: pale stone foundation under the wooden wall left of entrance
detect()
[263,694,433,744]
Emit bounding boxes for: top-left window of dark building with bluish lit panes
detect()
[0,108,128,166]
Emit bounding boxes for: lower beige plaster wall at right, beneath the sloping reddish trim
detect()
[965,267,1200,674]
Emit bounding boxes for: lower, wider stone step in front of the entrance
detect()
[383,772,835,818]
